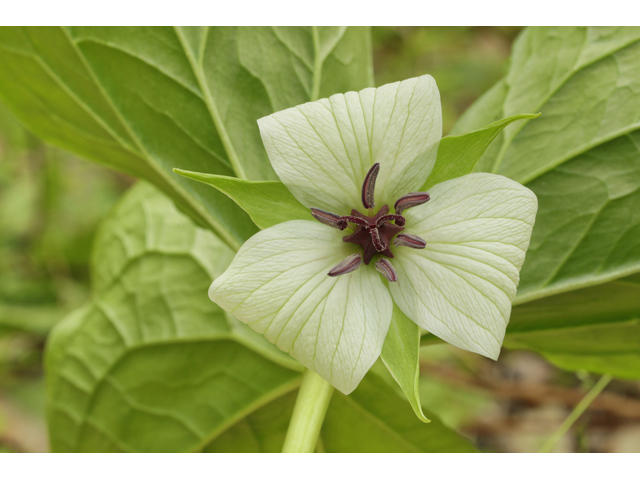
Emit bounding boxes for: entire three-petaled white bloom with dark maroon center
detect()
[209,75,537,393]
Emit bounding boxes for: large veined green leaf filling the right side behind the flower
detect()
[454,27,640,377]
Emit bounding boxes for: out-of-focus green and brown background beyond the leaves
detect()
[0,27,640,452]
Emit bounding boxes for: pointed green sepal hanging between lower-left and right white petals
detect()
[380,303,430,423]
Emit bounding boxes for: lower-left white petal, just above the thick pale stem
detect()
[209,220,393,394]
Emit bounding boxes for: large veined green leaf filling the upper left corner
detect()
[0,27,372,248]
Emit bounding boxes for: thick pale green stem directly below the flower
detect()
[282,370,333,453]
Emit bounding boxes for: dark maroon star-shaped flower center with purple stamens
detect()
[311,163,429,282]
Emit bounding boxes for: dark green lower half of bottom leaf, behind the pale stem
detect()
[204,373,475,453]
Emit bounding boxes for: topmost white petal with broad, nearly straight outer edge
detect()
[258,75,442,214]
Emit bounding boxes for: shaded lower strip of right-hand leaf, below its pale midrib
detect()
[504,274,640,379]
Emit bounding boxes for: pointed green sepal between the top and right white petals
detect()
[421,113,540,191]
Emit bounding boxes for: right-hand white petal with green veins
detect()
[390,173,538,359]
